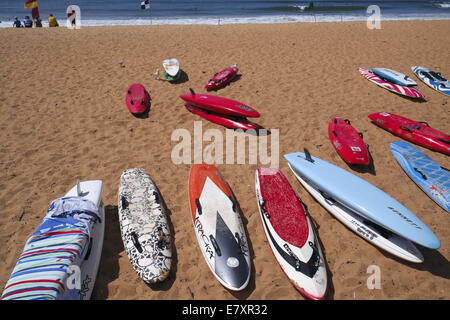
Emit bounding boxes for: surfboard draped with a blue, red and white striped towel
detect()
[2,180,105,300]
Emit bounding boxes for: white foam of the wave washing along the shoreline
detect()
[0,13,450,28]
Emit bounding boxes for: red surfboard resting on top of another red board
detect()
[180,90,260,118]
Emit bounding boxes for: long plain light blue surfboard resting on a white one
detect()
[284,152,440,249]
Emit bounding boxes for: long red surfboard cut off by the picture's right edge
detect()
[368,112,450,154]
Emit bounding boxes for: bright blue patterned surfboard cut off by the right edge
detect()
[391,142,450,212]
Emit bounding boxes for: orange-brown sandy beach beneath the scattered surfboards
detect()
[0,21,450,300]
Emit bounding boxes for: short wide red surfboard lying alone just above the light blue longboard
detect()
[328,118,370,165]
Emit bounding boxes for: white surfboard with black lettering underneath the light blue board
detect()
[288,163,424,263]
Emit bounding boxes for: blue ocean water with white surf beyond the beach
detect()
[0,0,450,27]
